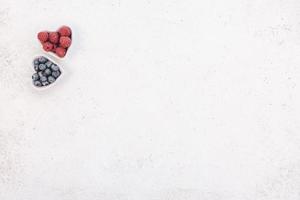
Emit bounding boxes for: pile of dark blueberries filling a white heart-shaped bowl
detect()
[32,56,61,87]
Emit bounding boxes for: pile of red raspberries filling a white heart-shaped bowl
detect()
[37,26,72,58]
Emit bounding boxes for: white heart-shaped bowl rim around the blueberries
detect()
[31,54,64,91]
